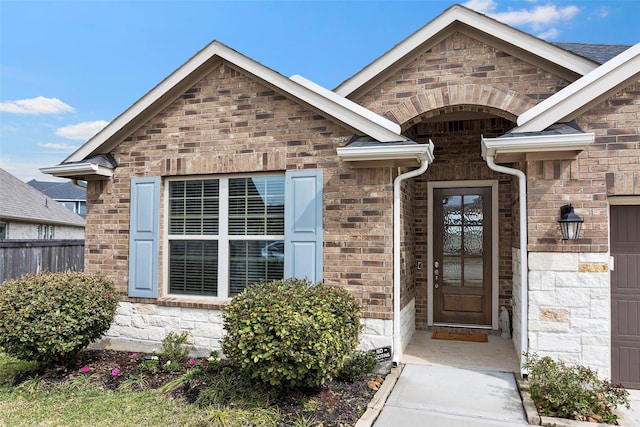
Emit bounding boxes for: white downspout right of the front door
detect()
[485,153,529,373]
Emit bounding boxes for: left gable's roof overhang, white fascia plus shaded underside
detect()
[56,41,406,170]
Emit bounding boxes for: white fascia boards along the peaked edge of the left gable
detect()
[65,41,406,162]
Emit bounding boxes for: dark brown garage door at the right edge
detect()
[611,206,640,389]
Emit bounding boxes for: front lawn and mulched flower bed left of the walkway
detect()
[0,352,374,427]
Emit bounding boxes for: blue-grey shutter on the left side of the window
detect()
[129,177,160,298]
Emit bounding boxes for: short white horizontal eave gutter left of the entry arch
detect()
[337,141,434,163]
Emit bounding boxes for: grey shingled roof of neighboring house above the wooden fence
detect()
[0,169,85,227]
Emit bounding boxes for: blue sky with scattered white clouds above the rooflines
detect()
[0,0,640,181]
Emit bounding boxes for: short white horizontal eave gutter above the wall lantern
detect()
[481,133,595,159]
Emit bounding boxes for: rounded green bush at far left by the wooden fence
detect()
[0,272,119,365]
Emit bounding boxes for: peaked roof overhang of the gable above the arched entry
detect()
[335,4,598,98]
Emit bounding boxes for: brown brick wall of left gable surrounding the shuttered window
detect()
[86,65,394,319]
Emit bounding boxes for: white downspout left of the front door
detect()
[393,141,433,365]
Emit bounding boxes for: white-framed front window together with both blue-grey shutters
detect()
[127,169,323,298]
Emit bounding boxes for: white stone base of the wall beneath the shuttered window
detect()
[99,302,396,356]
